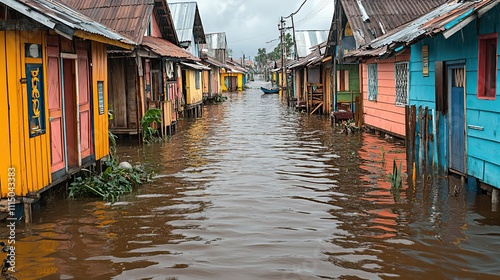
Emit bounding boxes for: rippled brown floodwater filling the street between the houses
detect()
[0,77,500,279]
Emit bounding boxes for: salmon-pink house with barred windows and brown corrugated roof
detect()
[327,0,446,131]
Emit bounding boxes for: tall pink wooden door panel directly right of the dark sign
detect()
[47,40,66,173]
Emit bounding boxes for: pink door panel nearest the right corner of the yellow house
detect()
[77,50,93,159]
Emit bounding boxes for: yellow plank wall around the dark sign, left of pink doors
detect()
[0,31,51,198]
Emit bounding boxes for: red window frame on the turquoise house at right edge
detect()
[477,33,498,100]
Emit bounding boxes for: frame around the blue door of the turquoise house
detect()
[446,60,468,175]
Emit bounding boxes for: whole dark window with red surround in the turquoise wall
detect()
[477,33,498,99]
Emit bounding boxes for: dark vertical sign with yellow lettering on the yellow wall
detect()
[26,64,45,137]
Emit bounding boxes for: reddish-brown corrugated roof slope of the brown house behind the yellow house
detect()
[60,0,154,44]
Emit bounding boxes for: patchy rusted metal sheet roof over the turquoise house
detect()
[346,0,500,57]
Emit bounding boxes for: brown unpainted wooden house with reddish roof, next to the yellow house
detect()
[63,0,199,135]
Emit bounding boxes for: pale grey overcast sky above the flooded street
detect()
[168,0,334,59]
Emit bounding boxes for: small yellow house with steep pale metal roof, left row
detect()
[168,2,206,117]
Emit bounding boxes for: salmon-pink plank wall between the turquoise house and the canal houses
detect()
[361,52,411,138]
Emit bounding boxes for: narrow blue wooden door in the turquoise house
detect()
[448,65,466,174]
